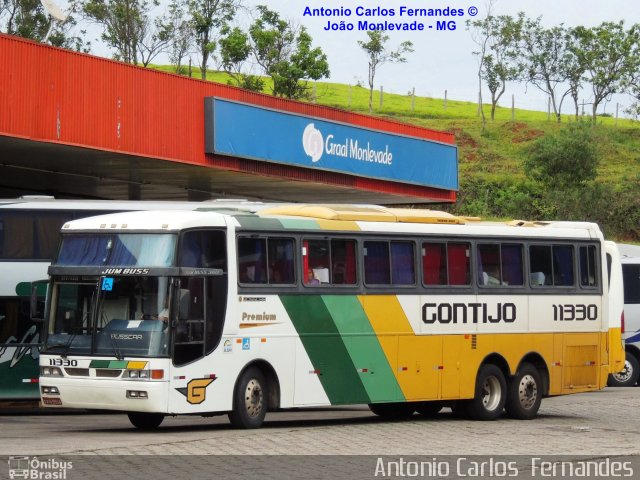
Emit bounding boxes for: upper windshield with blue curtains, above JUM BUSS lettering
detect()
[56,233,176,267]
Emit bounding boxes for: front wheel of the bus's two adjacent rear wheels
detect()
[467,363,507,420]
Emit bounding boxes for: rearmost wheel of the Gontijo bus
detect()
[505,363,543,420]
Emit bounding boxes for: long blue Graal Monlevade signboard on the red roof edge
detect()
[205,98,458,190]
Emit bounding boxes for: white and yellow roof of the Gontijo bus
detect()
[57,204,603,240]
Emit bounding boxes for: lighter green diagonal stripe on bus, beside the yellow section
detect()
[322,295,405,402]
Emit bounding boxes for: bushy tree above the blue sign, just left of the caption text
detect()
[249,5,329,98]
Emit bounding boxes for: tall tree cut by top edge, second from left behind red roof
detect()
[80,0,159,65]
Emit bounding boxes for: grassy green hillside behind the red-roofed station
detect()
[158,67,640,242]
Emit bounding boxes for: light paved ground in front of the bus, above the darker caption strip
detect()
[0,388,640,455]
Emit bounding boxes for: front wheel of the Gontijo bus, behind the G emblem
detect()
[229,367,269,428]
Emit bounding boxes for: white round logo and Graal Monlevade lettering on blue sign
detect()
[302,123,393,167]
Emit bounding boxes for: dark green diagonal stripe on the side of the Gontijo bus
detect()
[281,295,370,404]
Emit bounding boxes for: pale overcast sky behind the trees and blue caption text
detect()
[59,0,640,113]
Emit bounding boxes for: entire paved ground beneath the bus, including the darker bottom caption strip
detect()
[0,388,640,480]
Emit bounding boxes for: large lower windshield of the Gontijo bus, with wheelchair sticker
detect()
[45,276,170,359]
